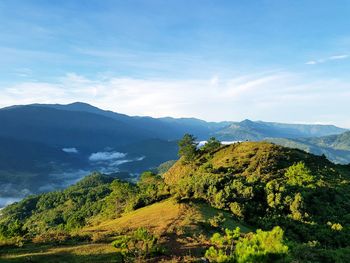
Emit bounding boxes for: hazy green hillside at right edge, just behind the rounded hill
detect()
[268,132,350,164]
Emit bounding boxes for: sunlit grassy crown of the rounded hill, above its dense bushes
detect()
[164,142,334,185]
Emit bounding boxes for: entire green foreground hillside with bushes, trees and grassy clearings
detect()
[0,142,350,262]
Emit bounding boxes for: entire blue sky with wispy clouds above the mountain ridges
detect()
[0,0,350,128]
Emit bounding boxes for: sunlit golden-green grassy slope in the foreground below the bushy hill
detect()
[0,199,252,262]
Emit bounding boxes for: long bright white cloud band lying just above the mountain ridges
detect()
[0,72,350,126]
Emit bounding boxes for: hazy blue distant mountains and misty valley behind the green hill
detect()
[0,102,350,207]
